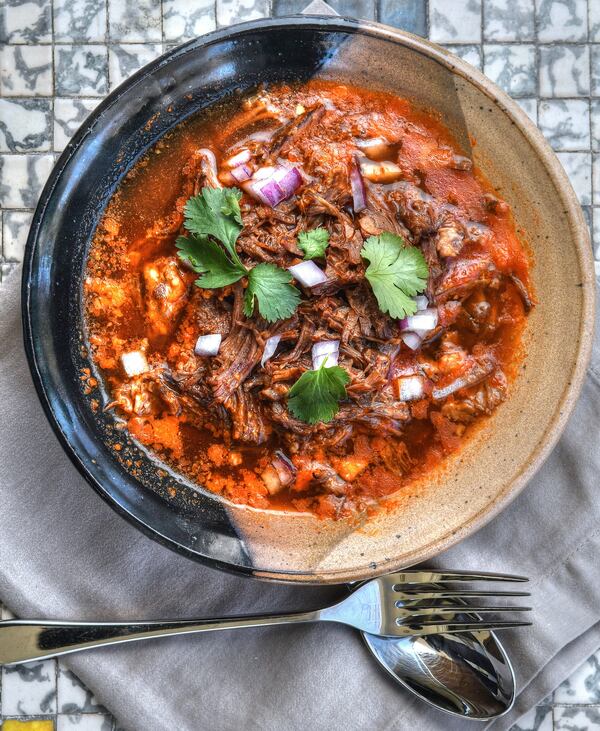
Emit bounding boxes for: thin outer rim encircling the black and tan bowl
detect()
[22,16,593,583]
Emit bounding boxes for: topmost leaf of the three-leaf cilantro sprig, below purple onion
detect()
[183,187,242,264]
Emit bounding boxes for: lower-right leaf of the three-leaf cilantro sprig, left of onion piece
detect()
[244,263,300,322]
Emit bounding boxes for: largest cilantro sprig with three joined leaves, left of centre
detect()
[175,188,300,322]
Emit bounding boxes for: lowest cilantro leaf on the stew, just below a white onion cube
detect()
[288,361,350,424]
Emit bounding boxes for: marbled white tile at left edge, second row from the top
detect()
[0,45,53,96]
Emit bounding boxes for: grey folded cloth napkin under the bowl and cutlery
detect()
[0,264,600,731]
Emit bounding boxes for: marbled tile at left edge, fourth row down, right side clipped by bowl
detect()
[0,153,54,208]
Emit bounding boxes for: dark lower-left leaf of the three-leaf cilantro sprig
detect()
[175,236,246,289]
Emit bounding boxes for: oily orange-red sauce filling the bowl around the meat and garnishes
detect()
[84,82,531,518]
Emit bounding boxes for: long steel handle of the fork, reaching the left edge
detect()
[0,611,321,665]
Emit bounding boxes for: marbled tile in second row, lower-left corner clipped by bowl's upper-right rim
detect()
[483,43,537,96]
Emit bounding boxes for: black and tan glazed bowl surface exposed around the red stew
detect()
[23,18,593,582]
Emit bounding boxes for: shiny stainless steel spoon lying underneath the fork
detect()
[361,588,515,720]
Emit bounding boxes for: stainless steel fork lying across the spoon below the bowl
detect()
[0,570,531,665]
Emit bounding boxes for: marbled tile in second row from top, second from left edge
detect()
[54,44,108,96]
